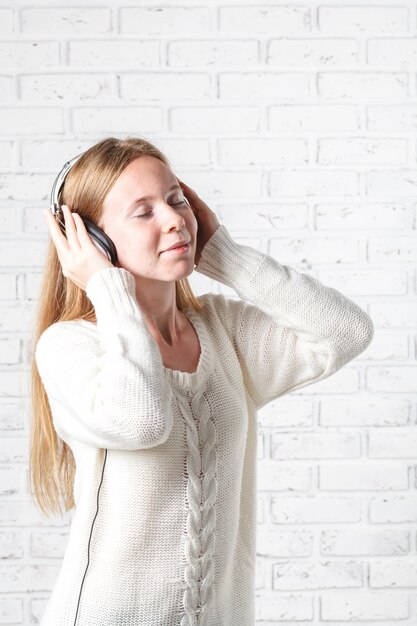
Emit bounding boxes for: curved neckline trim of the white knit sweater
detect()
[162,307,214,391]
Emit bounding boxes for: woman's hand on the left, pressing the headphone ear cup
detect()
[44,204,114,291]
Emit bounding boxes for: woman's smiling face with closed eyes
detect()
[99,155,197,281]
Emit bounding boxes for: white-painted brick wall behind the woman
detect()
[0,0,417,626]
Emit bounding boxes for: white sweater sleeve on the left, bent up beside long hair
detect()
[35,267,173,450]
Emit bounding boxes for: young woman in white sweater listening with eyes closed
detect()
[30,138,373,626]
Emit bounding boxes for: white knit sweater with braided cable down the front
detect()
[36,224,373,626]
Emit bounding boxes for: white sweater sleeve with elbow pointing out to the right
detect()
[195,224,374,408]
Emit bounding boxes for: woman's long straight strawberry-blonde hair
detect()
[29,137,203,515]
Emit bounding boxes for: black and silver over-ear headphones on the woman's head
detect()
[49,152,190,265]
